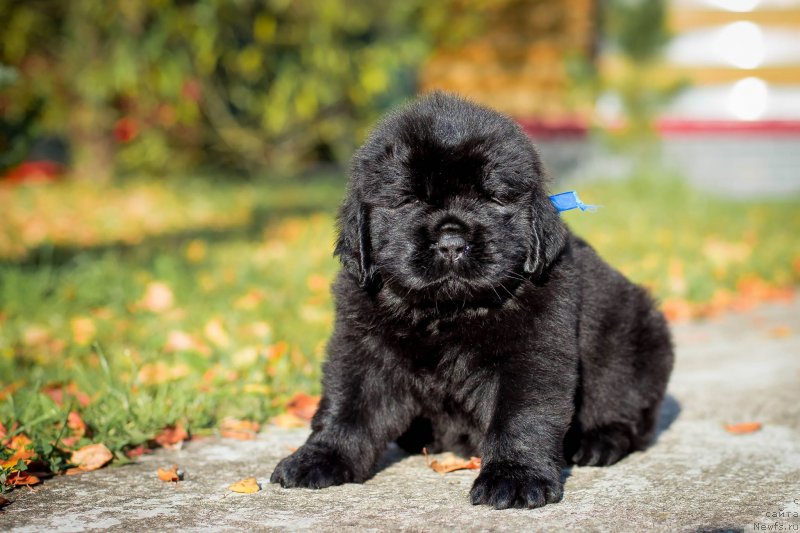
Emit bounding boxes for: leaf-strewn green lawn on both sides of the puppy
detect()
[0,171,800,486]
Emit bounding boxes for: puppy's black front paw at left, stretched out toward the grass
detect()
[269,444,353,489]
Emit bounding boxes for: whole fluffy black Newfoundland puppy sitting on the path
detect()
[271,93,673,509]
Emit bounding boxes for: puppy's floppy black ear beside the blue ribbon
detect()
[523,191,567,274]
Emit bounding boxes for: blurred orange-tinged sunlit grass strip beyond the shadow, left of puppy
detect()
[0,177,342,260]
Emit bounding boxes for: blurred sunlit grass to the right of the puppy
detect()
[564,175,800,314]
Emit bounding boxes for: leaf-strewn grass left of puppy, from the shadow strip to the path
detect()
[0,184,336,490]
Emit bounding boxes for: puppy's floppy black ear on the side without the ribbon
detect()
[333,191,374,287]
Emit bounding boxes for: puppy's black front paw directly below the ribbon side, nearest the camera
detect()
[470,463,564,509]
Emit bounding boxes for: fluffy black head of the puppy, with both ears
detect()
[336,93,565,302]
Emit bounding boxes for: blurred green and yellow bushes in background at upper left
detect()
[0,0,496,178]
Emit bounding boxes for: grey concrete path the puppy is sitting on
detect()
[0,298,800,532]
